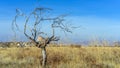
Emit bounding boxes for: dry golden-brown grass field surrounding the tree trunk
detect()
[0,46,120,68]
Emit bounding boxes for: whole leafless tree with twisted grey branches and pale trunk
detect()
[12,7,72,67]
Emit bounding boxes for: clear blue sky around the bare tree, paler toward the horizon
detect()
[0,0,120,42]
